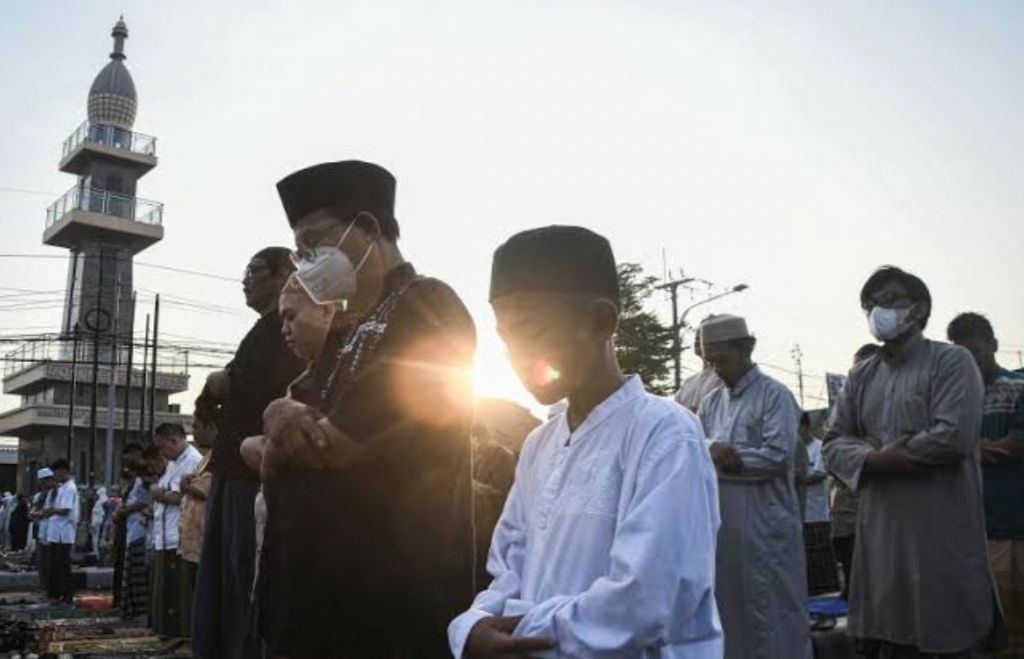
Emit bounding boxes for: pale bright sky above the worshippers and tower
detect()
[0,0,1024,419]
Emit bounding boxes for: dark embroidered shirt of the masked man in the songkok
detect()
[259,265,475,659]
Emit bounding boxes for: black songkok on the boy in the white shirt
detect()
[490,226,618,303]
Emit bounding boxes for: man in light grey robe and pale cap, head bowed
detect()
[700,315,811,659]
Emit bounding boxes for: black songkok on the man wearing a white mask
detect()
[278,161,395,226]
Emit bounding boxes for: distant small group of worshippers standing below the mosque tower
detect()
[27,421,207,636]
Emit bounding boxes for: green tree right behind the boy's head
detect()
[615,263,673,395]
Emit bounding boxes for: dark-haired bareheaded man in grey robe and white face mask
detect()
[824,266,998,659]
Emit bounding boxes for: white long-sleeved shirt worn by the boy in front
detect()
[449,377,722,659]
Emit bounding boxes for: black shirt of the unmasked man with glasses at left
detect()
[210,311,303,480]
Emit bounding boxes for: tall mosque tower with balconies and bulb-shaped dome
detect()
[0,16,190,491]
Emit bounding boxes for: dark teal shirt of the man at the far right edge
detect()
[981,369,1024,540]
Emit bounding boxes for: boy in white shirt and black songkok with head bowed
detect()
[449,227,722,659]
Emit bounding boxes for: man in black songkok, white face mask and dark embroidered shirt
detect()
[258,161,475,659]
